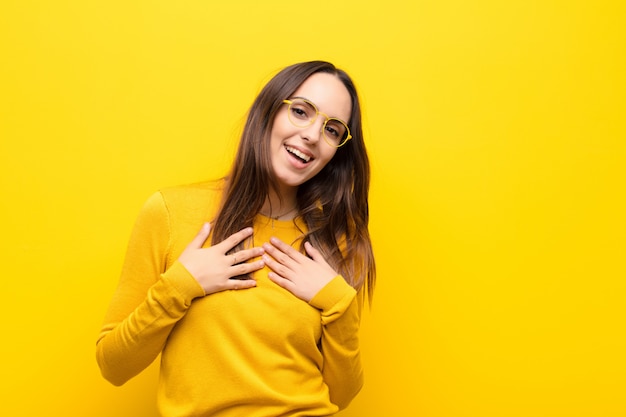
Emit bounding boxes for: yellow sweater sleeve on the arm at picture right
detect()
[310,276,363,410]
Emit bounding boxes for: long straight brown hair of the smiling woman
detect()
[212,61,376,300]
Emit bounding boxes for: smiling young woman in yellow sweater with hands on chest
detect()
[97,61,375,417]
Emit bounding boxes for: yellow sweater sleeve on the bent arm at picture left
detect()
[96,193,204,385]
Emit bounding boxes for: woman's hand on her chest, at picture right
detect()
[263,238,337,303]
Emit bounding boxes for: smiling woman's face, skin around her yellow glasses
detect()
[270,73,352,190]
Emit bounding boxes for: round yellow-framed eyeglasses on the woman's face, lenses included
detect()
[283,98,352,148]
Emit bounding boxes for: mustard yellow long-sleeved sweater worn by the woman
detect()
[96,183,363,417]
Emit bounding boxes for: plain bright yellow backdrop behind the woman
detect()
[0,0,626,417]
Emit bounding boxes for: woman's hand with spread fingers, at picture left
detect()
[178,223,265,295]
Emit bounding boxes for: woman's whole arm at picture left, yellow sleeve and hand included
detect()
[96,193,264,385]
